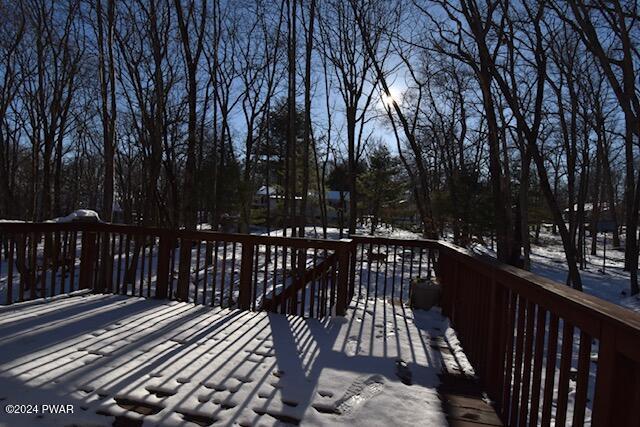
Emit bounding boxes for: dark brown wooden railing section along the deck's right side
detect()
[437,242,640,426]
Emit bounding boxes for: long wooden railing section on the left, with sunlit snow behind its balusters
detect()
[0,222,353,317]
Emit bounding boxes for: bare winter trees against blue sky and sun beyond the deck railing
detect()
[0,0,640,294]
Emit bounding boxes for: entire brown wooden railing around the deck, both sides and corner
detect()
[0,223,640,426]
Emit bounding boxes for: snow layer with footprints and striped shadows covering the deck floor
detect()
[0,295,466,426]
